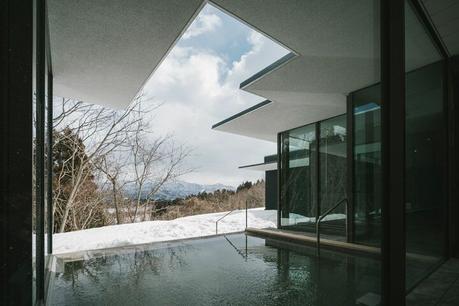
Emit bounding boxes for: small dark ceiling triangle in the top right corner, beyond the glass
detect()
[422,0,459,55]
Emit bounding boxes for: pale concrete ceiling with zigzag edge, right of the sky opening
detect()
[213,0,450,141]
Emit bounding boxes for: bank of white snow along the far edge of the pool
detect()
[53,207,277,254]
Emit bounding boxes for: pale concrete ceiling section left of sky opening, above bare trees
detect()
[47,0,203,108]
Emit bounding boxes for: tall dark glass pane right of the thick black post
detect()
[405,2,447,290]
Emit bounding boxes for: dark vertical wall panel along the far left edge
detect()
[0,0,33,305]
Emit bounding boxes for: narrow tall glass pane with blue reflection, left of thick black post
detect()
[351,85,382,246]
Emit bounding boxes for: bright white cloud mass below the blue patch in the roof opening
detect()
[145,24,286,185]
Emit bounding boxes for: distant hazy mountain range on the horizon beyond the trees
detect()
[125,181,236,200]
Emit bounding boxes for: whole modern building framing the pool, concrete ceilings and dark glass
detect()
[0,0,459,305]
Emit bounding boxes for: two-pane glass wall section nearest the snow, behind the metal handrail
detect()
[281,115,347,236]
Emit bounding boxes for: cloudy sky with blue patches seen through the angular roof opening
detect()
[144,4,288,186]
